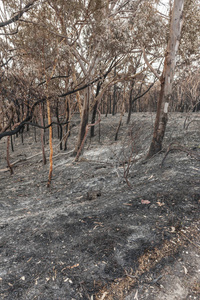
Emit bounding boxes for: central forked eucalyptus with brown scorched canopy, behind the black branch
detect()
[43,0,147,153]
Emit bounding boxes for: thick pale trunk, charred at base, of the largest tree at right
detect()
[147,0,184,158]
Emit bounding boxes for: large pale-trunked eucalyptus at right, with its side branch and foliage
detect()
[143,0,199,158]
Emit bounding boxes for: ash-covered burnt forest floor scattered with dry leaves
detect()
[0,113,200,300]
